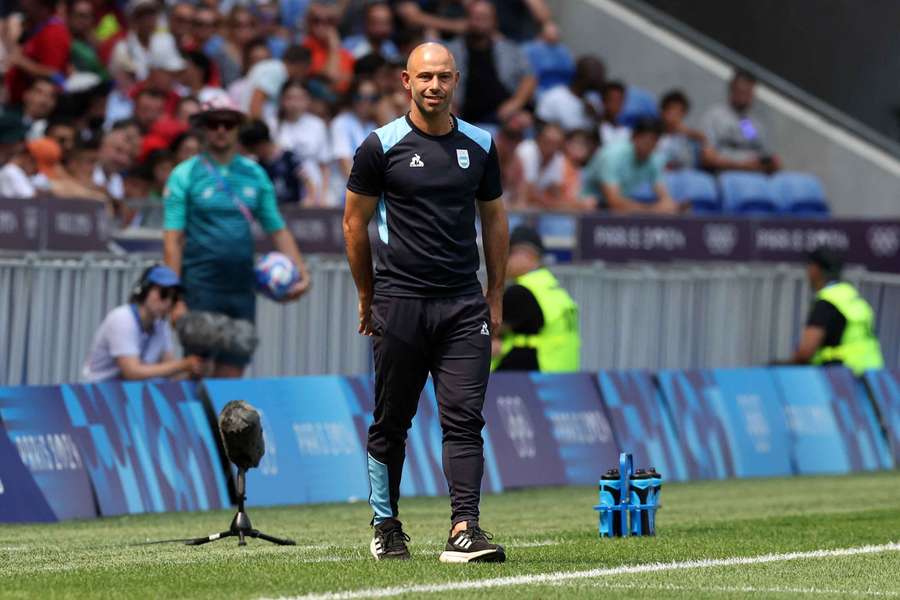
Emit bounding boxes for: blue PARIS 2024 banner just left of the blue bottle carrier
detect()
[529,373,619,484]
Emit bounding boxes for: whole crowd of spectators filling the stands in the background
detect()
[0,0,780,227]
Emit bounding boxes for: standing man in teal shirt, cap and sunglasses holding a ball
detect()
[163,94,309,377]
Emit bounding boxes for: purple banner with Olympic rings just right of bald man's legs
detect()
[484,372,566,488]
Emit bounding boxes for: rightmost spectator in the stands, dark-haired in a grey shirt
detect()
[703,71,781,173]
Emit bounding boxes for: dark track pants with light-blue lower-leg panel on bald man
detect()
[367,294,491,524]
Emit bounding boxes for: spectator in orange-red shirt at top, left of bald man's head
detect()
[303,0,353,93]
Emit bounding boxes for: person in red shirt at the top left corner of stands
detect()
[6,0,72,104]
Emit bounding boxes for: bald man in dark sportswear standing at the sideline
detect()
[344,43,509,563]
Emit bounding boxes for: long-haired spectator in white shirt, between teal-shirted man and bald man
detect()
[269,79,331,206]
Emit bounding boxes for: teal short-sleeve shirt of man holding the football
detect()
[163,154,284,291]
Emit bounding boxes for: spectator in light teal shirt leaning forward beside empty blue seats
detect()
[584,117,683,215]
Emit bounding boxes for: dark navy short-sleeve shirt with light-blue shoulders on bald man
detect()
[347,115,503,298]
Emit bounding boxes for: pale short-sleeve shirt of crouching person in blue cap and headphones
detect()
[82,304,173,383]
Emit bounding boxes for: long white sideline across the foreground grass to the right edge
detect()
[264,542,900,600]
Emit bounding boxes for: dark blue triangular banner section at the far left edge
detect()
[0,426,56,523]
